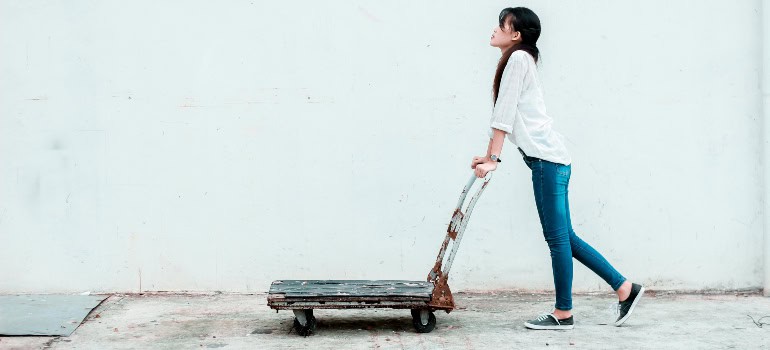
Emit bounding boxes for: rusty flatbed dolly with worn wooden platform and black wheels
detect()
[267,172,492,336]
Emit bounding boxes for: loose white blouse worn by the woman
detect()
[489,50,572,165]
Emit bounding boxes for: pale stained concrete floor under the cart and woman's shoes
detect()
[0,292,770,350]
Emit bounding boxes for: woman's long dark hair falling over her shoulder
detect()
[492,7,540,103]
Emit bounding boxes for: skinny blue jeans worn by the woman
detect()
[522,152,626,310]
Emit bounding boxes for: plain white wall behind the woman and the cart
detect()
[0,0,766,293]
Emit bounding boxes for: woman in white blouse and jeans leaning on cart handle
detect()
[471,7,644,329]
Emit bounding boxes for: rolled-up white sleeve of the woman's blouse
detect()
[489,51,528,135]
